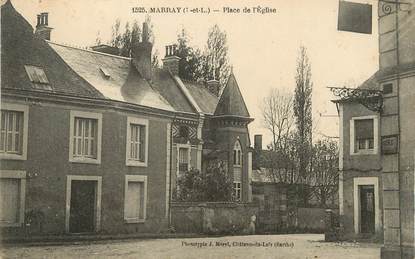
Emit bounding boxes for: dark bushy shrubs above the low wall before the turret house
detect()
[176,161,233,202]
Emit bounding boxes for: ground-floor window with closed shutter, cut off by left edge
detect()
[0,171,26,226]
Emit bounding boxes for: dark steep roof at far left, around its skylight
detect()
[1,1,102,98]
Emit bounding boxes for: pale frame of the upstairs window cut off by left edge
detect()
[0,102,29,160]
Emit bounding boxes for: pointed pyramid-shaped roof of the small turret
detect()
[214,73,250,118]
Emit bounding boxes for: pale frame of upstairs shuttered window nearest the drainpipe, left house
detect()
[125,117,149,167]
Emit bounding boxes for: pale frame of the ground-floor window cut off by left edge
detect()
[0,170,26,227]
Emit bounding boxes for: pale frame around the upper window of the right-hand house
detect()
[350,115,379,155]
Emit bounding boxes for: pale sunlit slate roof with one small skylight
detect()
[49,42,174,111]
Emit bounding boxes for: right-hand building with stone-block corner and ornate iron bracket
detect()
[335,1,415,258]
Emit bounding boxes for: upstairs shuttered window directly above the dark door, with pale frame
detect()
[69,111,102,164]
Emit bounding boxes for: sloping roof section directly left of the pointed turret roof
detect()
[182,80,219,114]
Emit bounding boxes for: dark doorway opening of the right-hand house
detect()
[359,185,375,234]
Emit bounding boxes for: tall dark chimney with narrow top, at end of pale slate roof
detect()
[131,22,153,80]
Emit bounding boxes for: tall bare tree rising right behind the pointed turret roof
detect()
[203,24,230,87]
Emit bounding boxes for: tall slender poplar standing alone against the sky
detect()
[294,46,313,183]
